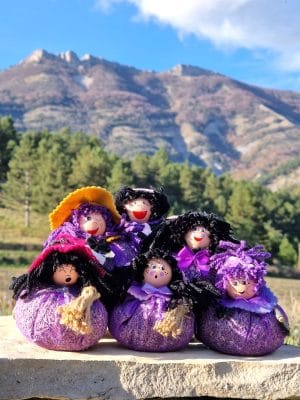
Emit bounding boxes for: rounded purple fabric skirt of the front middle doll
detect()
[108,299,195,352]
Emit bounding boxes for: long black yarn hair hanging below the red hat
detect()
[10,251,113,302]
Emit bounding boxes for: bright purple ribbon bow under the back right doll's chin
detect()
[176,246,210,271]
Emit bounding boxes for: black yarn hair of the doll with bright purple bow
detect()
[150,211,239,253]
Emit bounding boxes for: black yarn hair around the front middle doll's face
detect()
[132,249,183,283]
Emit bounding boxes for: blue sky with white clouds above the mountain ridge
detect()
[0,0,300,91]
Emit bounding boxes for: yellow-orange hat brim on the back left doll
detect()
[49,186,121,230]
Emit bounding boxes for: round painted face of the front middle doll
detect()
[144,258,172,288]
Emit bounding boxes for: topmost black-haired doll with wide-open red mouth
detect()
[114,186,170,253]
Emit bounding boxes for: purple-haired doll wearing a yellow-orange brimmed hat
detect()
[45,186,136,271]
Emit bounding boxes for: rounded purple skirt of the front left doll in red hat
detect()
[13,289,107,351]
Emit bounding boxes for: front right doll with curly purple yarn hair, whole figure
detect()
[196,241,288,356]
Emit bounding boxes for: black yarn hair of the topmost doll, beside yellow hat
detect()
[114,186,170,221]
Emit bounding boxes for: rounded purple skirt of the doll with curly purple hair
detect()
[196,307,287,356]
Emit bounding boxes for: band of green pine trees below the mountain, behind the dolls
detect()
[0,117,300,269]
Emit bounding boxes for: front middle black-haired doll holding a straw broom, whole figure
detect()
[108,249,194,352]
